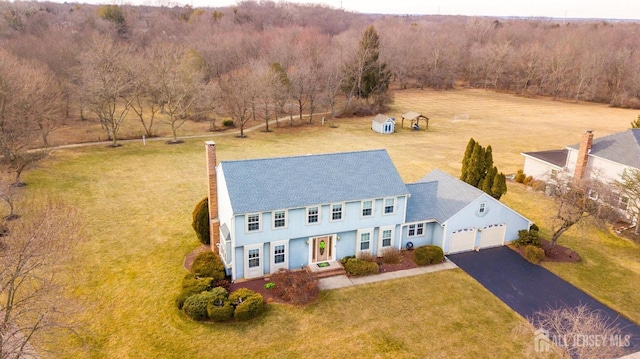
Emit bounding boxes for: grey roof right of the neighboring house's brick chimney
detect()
[568,128,640,168]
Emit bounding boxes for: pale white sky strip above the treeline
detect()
[125,0,640,20]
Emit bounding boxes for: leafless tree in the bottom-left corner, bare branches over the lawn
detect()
[0,200,81,358]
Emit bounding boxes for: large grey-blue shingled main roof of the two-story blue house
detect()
[220,150,409,214]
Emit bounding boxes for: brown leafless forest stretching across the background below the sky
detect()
[0,1,640,148]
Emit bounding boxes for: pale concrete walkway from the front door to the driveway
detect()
[318,262,457,290]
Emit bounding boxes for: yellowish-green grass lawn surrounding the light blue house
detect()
[20,90,640,358]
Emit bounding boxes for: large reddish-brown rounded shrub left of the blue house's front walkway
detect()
[271,269,320,305]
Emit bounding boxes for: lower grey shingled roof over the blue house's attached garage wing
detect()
[406,170,484,223]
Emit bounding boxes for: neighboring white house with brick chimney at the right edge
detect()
[522,129,640,220]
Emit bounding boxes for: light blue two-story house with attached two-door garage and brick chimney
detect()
[206,141,530,280]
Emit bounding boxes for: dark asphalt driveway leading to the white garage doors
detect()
[447,247,640,350]
